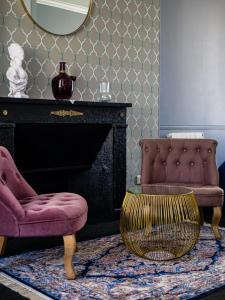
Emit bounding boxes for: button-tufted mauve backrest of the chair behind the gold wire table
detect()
[140,139,219,185]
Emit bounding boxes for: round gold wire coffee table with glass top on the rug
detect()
[120,185,200,260]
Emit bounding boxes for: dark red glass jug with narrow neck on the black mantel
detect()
[52,62,76,100]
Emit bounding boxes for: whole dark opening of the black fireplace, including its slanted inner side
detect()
[14,123,114,223]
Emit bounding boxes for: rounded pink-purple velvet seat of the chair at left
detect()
[18,193,88,237]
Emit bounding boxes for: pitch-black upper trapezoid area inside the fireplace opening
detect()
[15,123,111,174]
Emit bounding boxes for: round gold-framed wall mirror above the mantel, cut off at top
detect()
[21,0,92,35]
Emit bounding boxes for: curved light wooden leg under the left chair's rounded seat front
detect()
[63,234,76,279]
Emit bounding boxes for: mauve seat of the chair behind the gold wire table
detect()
[142,182,224,207]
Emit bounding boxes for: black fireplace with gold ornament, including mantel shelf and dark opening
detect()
[0,97,131,239]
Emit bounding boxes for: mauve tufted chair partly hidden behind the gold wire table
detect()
[140,139,224,239]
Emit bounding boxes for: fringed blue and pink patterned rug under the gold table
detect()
[0,226,225,300]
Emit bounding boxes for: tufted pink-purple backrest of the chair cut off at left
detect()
[0,146,37,218]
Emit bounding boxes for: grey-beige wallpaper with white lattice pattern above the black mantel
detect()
[0,0,160,186]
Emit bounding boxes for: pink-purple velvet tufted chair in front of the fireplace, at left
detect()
[0,146,88,279]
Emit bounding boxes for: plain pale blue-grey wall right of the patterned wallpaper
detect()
[160,0,225,164]
